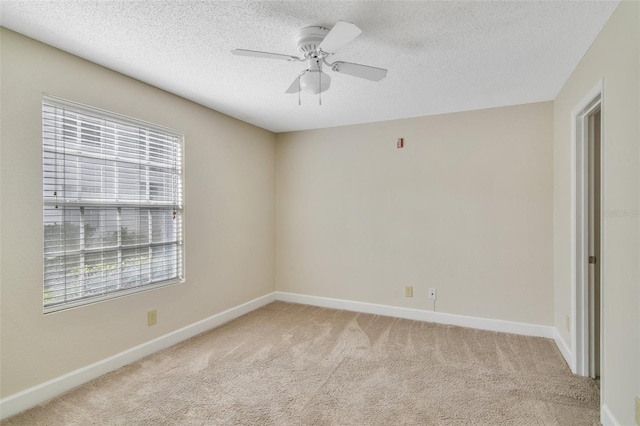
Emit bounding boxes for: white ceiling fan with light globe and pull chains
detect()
[231,21,387,104]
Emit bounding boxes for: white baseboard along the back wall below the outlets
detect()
[276,291,555,339]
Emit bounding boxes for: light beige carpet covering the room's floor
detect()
[1,302,599,426]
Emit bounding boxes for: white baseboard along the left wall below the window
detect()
[0,293,275,419]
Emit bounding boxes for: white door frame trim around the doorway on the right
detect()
[571,80,606,378]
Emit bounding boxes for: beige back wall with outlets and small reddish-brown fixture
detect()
[276,102,553,325]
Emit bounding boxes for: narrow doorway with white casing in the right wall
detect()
[571,81,605,386]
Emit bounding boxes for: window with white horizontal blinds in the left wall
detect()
[42,96,184,312]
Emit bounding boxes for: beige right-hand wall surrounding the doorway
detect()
[554,1,640,424]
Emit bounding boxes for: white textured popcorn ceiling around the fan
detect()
[0,0,619,132]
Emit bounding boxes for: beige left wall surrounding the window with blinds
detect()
[0,29,275,397]
